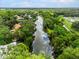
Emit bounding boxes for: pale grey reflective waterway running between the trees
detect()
[32,16,53,59]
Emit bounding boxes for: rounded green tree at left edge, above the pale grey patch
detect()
[0,25,12,44]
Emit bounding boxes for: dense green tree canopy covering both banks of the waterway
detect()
[0,9,79,59]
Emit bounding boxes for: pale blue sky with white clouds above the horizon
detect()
[0,0,79,8]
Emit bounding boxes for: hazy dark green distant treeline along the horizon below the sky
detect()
[0,8,79,17]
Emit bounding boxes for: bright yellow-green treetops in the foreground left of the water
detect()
[4,43,45,59]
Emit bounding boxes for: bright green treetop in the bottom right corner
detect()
[57,47,79,59]
